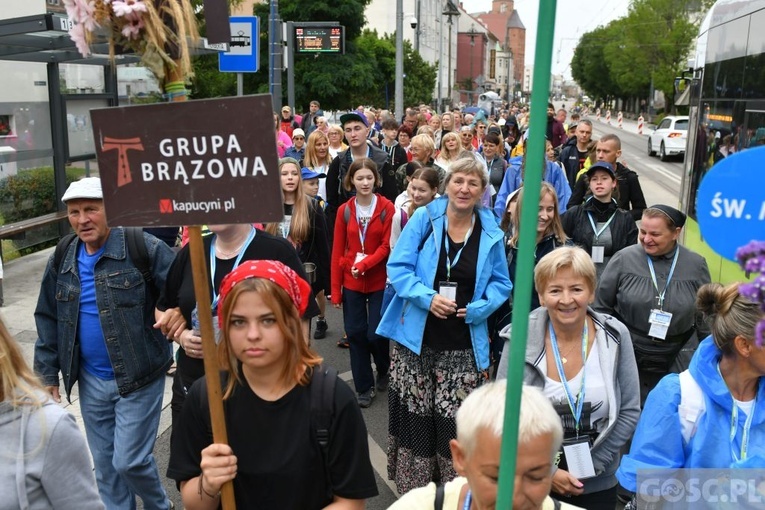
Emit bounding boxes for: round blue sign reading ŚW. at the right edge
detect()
[696,147,765,261]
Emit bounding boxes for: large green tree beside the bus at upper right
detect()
[571,0,714,109]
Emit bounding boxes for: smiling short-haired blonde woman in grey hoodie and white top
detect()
[497,246,640,508]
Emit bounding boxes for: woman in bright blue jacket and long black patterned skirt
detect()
[377,157,512,494]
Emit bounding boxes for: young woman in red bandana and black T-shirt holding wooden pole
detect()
[168,260,377,510]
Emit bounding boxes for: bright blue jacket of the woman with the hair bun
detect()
[616,336,765,492]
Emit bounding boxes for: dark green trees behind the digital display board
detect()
[192,0,437,112]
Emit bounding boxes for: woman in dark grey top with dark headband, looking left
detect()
[594,205,710,403]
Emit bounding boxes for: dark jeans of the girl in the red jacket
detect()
[343,289,390,394]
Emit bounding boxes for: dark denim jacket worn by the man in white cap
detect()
[34,228,175,400]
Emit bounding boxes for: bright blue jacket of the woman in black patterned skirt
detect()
[377,197,513,370]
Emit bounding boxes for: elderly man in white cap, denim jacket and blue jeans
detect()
[34,177,174,510]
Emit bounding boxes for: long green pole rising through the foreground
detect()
[497,0,556,510]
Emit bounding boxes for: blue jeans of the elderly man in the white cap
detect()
[79,370,170,510]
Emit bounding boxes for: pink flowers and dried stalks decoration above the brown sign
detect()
[64,0,199,81]
